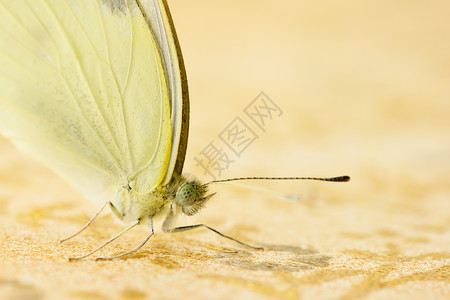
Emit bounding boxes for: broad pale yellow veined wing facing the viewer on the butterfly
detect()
[0,0,184,201]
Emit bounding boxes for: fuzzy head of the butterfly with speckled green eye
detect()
[175,180,215,216]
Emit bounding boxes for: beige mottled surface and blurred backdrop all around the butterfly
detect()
[0,0,450,299]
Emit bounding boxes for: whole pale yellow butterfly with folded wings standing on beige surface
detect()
[0,0,349,260]
